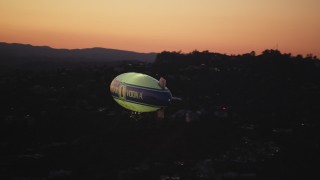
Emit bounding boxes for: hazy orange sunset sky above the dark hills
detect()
[0,0,320,57]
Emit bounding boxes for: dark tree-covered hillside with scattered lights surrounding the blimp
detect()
[0,47,320,180]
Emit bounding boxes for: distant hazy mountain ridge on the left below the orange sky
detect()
[0,42,156,62]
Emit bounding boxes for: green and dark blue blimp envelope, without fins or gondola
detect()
[110,72,172,112]
